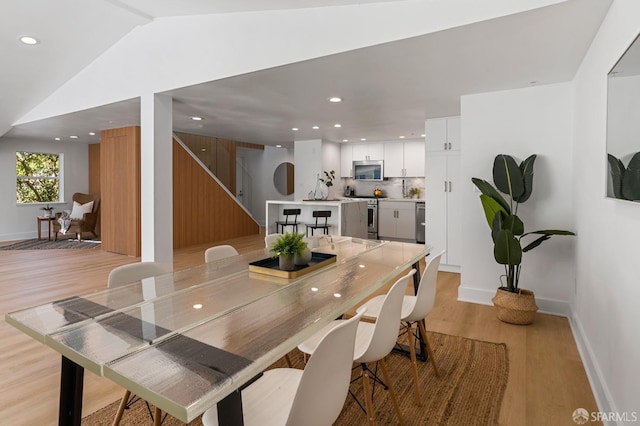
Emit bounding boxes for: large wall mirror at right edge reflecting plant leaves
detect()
[607,31,640,202]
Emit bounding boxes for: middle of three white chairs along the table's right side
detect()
[298,269,416,425]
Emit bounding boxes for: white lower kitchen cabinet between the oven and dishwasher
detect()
[378,200,416,241]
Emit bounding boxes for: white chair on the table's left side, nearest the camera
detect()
[107,262,169,426]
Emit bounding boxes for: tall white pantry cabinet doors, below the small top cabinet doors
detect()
[425,152,462,266]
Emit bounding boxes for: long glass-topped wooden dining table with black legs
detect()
[5,237,432,425]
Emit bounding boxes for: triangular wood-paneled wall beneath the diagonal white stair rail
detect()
[173,137,259,248]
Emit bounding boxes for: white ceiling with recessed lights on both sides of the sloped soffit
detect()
[0,0,611,145]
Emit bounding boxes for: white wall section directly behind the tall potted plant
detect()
[459,83,575,314]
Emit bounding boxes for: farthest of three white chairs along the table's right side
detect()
[362,250,445,405]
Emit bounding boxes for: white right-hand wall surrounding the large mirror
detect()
[572,0,640,420]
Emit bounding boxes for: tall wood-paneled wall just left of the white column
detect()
[100,126,141,257]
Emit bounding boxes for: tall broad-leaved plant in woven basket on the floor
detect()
[471,154,575,324]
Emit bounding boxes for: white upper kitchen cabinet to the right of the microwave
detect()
[384,140,424,177]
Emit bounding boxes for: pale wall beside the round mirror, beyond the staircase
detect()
[236,146,297,226]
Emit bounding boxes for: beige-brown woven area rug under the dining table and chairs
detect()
[82,332,509,426]
